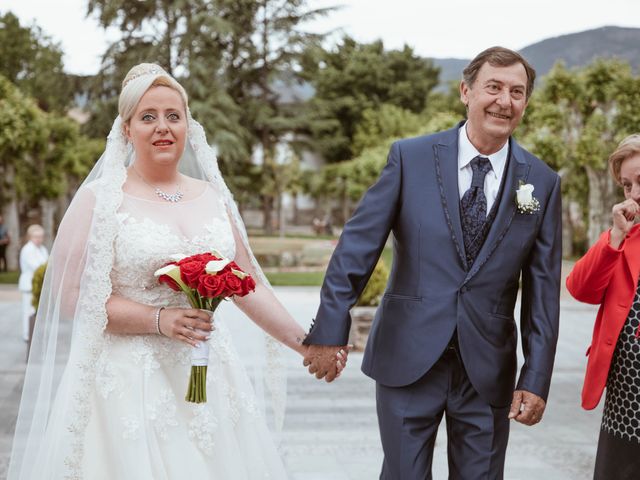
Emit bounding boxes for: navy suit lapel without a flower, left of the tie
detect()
[433,125,466,268]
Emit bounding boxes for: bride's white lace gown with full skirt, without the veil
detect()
[75,186,286,480]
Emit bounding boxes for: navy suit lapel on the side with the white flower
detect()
[465,139,531,282]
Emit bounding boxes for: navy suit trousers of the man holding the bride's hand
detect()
[376,336,509,480]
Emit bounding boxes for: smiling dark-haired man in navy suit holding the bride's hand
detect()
[304,47,561,480]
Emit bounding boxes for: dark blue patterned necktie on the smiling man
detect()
[460,156,491,268]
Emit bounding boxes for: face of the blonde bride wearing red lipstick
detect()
[125,86,187,165]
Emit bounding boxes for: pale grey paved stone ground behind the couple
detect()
[0,287,601,480]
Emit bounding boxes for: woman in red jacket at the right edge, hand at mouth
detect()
[567,134,640,480]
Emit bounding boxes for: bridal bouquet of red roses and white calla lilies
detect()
[154,250,256,403]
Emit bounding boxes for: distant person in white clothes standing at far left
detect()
[18,225,49,342]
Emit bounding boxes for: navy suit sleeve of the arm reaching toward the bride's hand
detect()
[304,143,402,345]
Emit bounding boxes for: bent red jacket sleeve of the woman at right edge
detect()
[567,230,624,304]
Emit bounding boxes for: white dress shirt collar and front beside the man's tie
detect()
[458,122,509,215]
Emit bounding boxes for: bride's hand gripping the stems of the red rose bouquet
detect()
[159,308,215,347]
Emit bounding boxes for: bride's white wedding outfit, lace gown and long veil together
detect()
[7,64,286,480]
